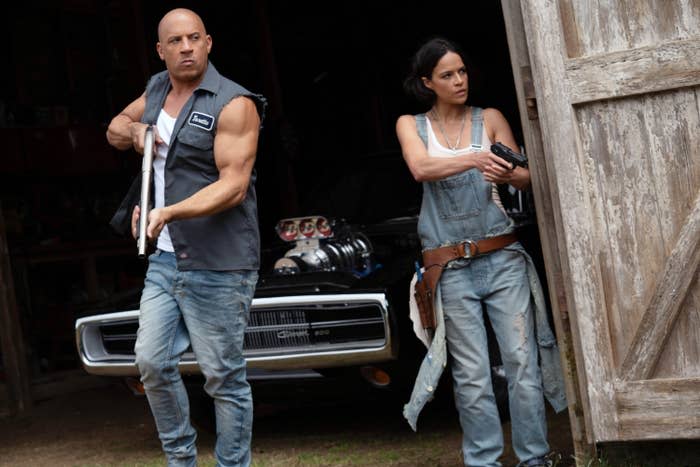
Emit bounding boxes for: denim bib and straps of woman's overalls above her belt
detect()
[415,107,514,250]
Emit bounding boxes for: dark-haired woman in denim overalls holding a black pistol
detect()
[396,38,566,467]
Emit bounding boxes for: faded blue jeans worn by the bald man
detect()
[135,250,257,466]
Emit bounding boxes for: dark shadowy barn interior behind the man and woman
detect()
[0,0,522,406]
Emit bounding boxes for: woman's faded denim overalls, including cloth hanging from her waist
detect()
[404,108,566,466]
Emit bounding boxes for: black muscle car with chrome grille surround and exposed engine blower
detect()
[75,153,526,418]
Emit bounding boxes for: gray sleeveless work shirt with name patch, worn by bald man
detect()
[141,62,265,271]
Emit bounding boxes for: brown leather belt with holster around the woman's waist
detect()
[414,234,518,330]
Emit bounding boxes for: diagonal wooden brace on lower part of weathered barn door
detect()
[620,193,700,381]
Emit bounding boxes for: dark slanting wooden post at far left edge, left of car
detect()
[0,206,32,413]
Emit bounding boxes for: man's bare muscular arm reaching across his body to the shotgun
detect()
[148,97,260,238]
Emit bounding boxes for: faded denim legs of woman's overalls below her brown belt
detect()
[440,250,549,466]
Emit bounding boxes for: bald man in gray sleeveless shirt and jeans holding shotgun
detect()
[107,9,265,466]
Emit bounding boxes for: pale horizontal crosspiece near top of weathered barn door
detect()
[566,38,700,104]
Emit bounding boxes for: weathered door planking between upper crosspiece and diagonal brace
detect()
[576,89,700,365]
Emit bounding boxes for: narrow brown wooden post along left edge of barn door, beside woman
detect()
[501,0,595,459]
